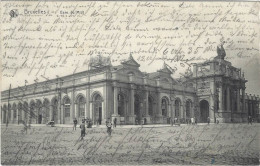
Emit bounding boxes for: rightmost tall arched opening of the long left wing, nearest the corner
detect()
[93,94,102,124]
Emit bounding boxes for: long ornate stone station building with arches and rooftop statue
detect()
[1,47,260,124]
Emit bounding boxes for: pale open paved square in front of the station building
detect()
[1,124,260,165]
